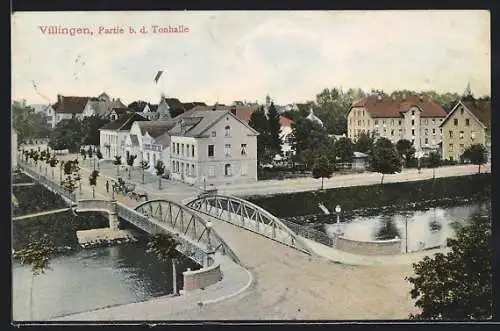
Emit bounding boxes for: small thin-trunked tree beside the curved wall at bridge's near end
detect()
[146,233,182,295]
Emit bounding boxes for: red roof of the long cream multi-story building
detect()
[351,95,447,118]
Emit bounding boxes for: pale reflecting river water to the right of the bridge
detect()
[325,203,486,252]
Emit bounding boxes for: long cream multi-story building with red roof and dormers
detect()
[347,94,447,152]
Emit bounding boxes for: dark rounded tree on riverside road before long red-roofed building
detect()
[369,138,401,184]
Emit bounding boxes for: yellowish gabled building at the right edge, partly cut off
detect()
[441,100,491,160]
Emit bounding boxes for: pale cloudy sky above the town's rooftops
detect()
[12,10,491,104]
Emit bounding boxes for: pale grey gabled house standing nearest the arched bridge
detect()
[170,110,258,185]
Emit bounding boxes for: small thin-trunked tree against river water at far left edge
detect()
[12,235,57,317]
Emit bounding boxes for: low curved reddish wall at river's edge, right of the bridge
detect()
[334,236,402,255]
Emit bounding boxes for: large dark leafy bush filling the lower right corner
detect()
[407,215,493,320]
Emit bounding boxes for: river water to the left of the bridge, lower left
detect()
[12,237,197,321]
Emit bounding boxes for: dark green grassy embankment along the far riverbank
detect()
[244,173,491,217]
